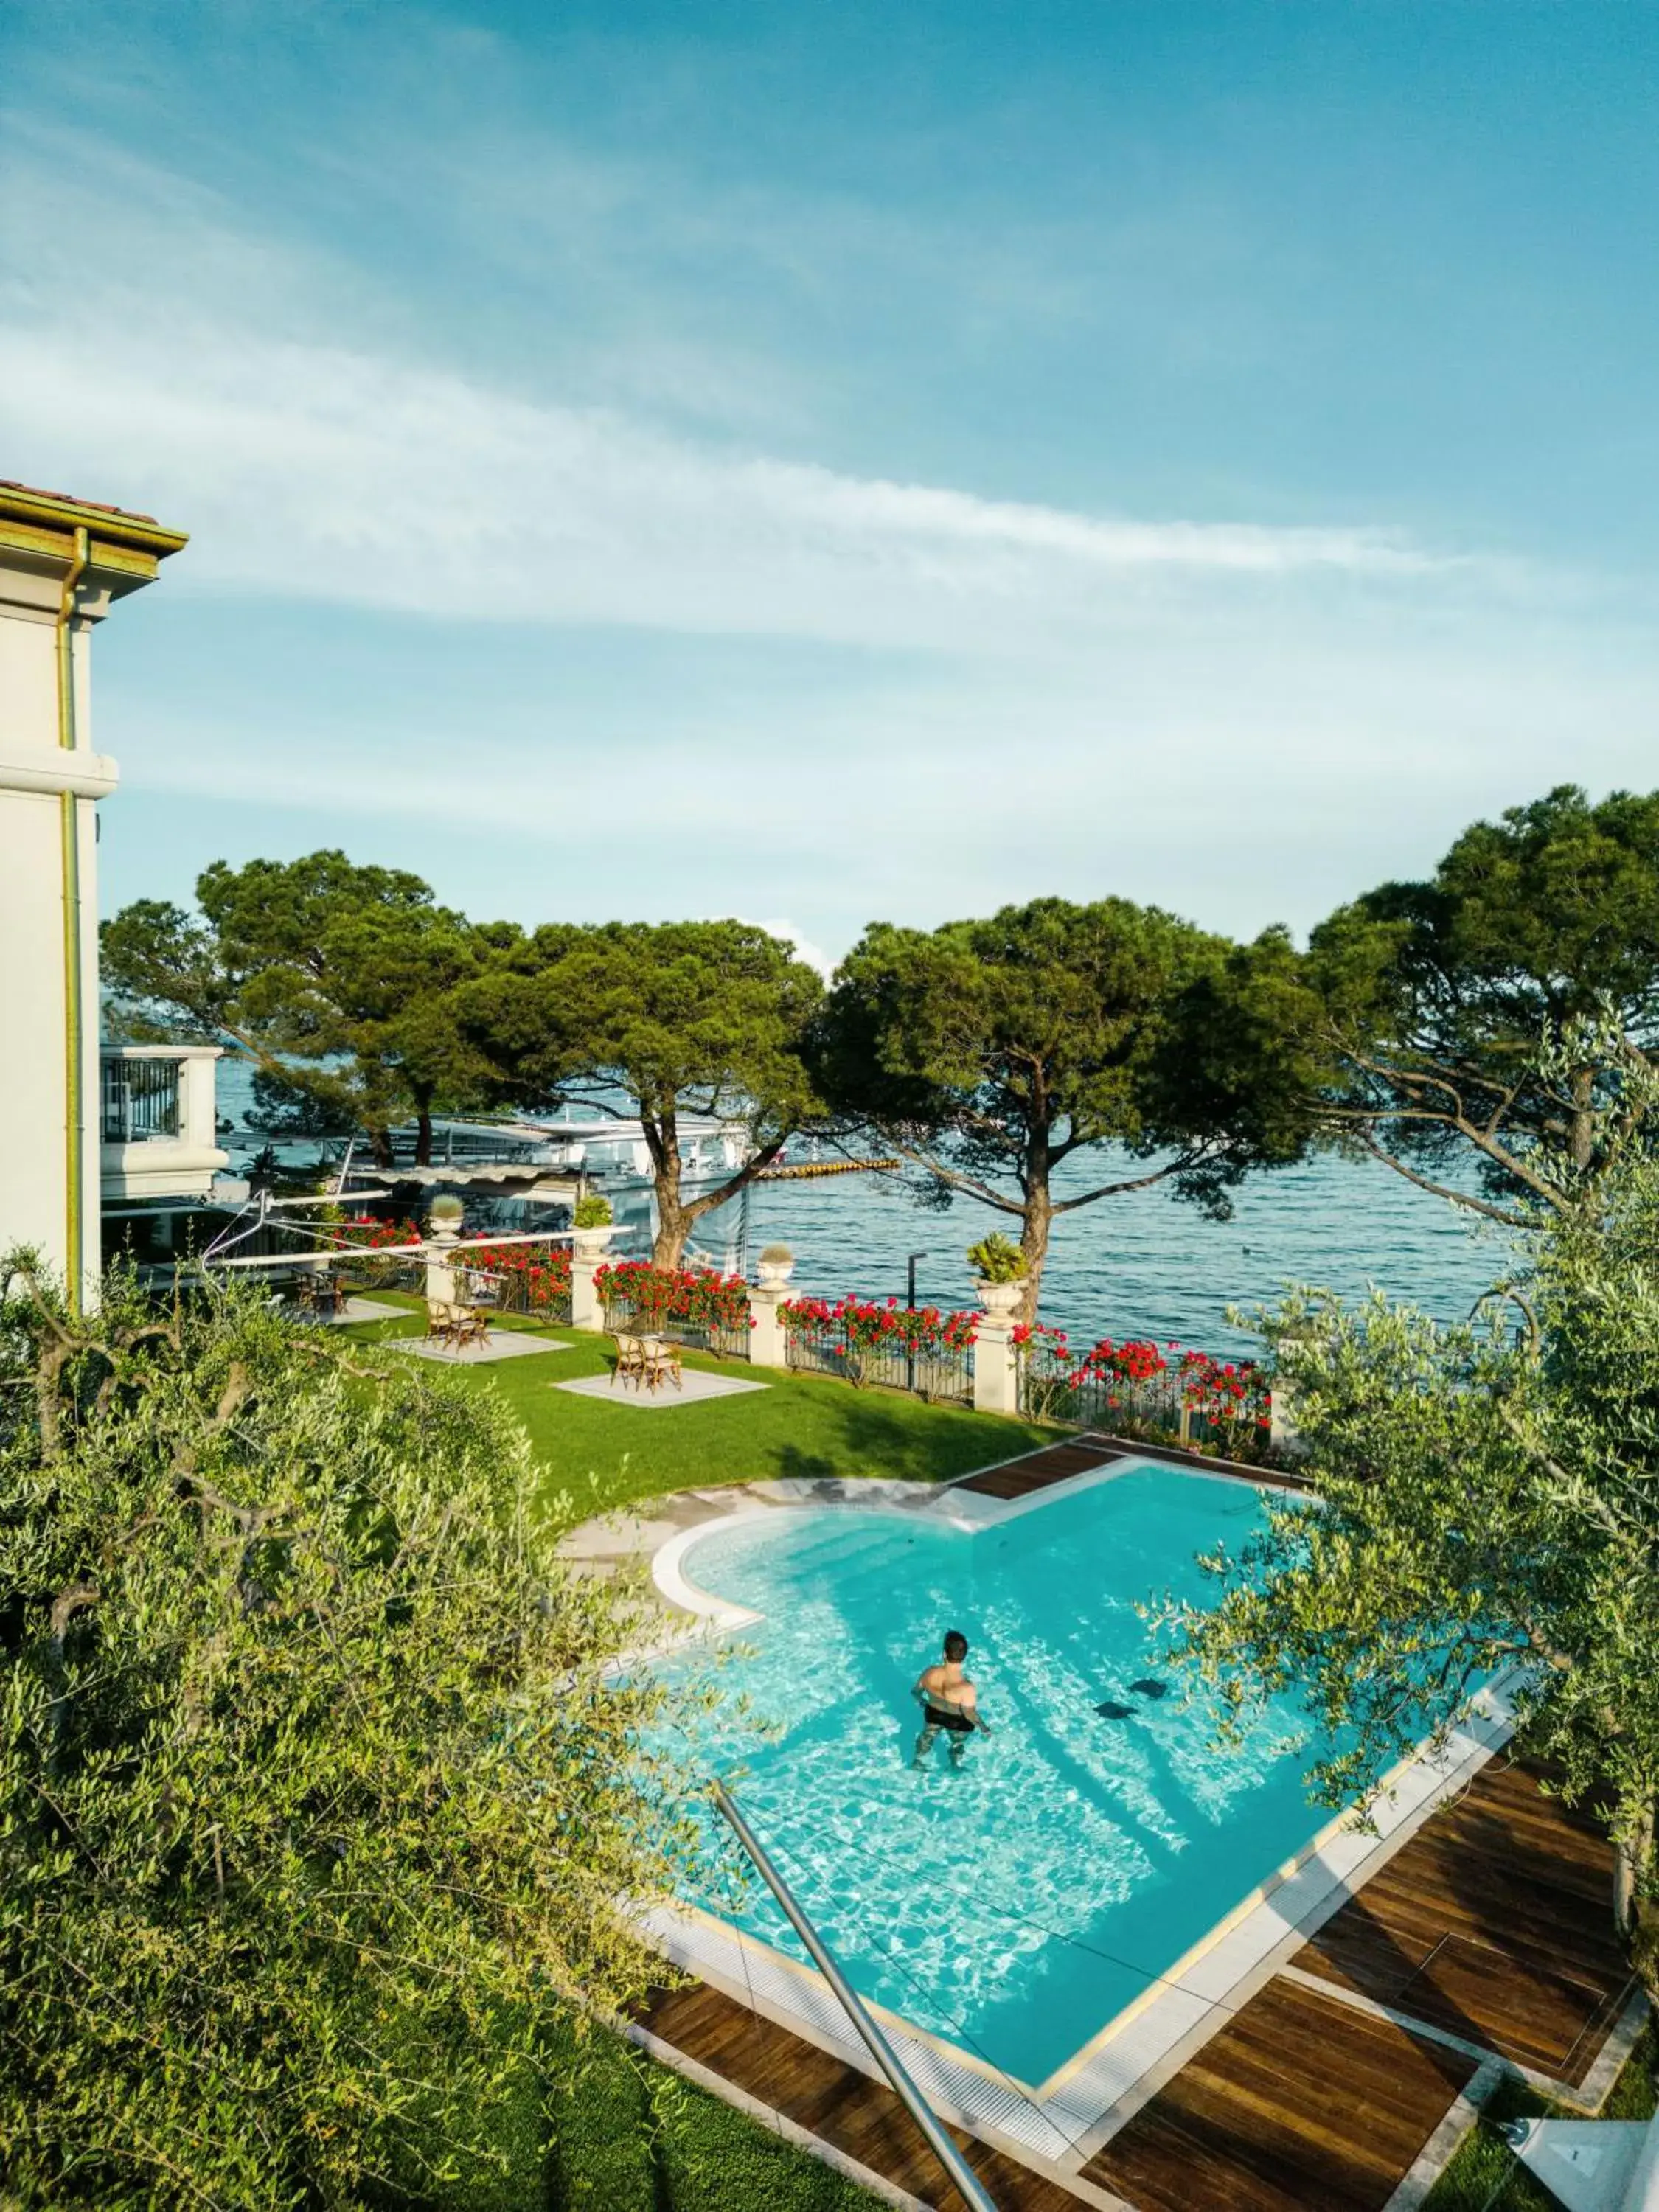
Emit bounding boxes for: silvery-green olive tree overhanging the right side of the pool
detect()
[1168,1033,1659,1955]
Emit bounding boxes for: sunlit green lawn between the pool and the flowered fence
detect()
[352,1294,1053,1520]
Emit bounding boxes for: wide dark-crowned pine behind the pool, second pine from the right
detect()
[814,898,1310,1321]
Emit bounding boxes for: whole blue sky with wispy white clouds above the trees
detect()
[0,0,1659,953]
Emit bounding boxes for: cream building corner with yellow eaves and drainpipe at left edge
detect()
[0,484,184,1305]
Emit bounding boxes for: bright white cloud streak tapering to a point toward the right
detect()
[0,122,1460,653]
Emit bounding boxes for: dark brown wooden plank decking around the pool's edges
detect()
[635,1438,1635,2212]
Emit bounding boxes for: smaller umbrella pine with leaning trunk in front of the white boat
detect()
[458,920,823,1267]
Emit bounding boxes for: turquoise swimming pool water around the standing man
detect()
[664,1467,1329,2084]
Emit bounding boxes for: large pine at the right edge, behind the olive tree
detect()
[1305,783,1659,1225]
